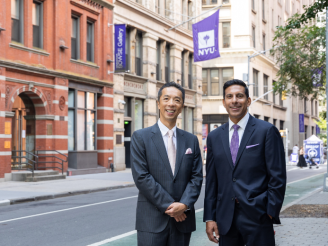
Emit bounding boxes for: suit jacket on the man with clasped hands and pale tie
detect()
[131,123,203,233]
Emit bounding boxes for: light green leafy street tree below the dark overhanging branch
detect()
[271,13,326,98]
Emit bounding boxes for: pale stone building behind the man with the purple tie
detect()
[202,0,318,154]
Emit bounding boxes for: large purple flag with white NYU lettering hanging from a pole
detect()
[192,10,220,62]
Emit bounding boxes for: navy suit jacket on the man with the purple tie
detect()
[204,115,286,235]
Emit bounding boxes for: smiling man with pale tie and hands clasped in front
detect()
[131,82,203,246]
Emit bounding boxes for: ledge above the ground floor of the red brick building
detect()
[0,59,114,87]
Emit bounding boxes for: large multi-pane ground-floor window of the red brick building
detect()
[68,89,97,150]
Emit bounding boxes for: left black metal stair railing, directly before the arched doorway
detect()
[11,150,39,177]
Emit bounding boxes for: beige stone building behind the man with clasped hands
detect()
[113,0,202,170]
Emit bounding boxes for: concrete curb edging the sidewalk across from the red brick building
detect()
[5,184,136,206]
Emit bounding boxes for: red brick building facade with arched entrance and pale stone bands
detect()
[0,0,114,181]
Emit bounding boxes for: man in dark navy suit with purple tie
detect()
[204,79,286,246]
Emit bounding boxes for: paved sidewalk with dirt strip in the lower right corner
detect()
[275,189,328,246]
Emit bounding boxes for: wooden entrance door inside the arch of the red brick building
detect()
[11,93,35,167]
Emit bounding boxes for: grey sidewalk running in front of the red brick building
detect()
[0,169,134,206]
